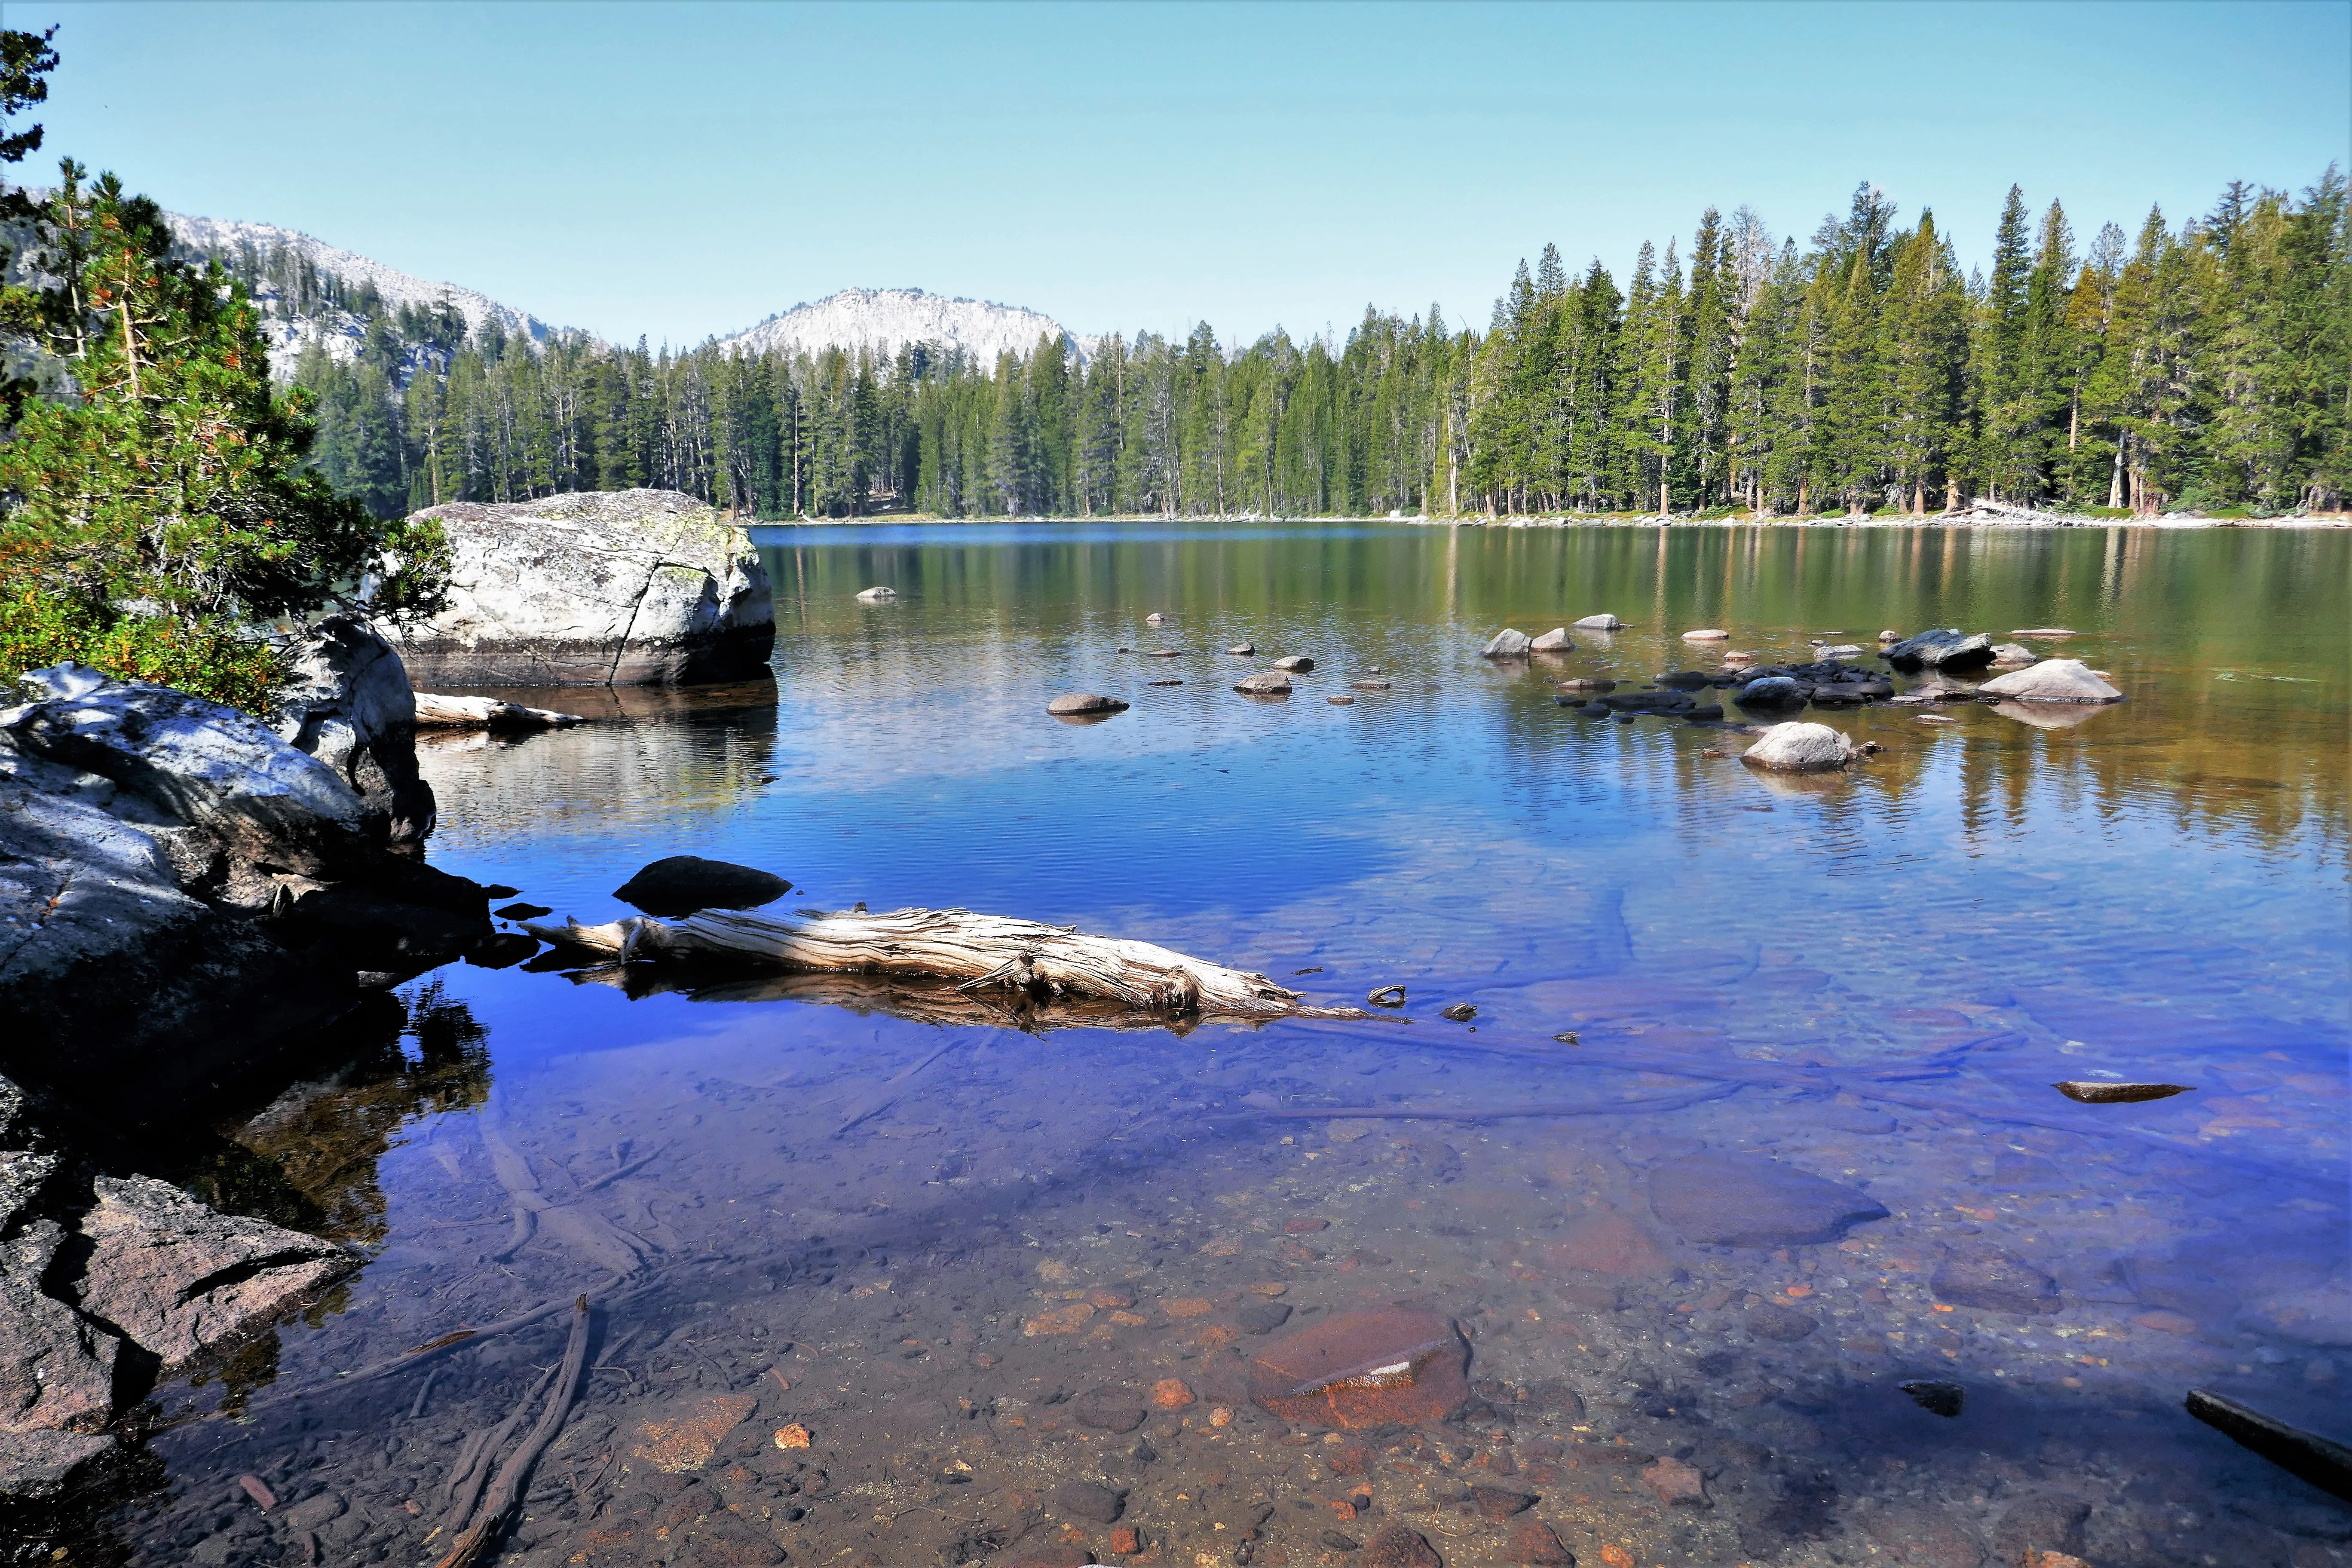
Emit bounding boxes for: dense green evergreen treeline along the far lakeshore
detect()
[280,167,2352,517]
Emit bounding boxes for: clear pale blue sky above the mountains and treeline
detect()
[0,0,2352,346]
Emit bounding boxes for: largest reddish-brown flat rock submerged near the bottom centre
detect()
[1249,1307,1470,1429]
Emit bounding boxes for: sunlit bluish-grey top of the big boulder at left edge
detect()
[0,665,374,877]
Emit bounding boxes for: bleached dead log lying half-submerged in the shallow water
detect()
[522,910,1369,1018]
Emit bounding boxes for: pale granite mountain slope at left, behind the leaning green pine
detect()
[165,211,560,376]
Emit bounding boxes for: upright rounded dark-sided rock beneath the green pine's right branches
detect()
[275,616,433,844]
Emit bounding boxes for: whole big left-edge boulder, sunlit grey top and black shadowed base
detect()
[0,665,492,1102]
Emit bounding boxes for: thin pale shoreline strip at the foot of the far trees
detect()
[736,510,2352,529]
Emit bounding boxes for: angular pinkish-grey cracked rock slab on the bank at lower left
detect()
[80,1176,360,1373]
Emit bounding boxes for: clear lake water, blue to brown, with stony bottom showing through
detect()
[125,524,2352,1568]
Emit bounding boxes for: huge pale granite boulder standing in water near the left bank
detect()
[398,489,776,689]
